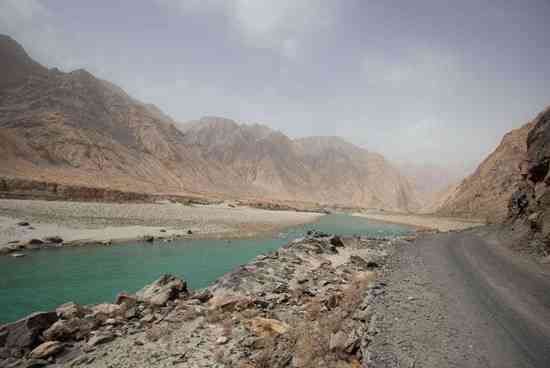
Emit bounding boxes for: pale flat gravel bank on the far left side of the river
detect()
[0,199,322,253]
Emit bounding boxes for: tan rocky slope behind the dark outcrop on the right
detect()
[436,122,534,222]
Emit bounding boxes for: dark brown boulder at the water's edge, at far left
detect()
[0,312,58,351]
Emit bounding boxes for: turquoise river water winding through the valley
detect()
[0,215,412,324]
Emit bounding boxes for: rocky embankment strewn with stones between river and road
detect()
[0,234,414,368]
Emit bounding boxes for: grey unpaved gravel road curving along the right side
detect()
[370,229,550,368]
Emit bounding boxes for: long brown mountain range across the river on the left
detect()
[0,36,418,210]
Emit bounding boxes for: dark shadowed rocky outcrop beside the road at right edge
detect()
[509,107,550,255]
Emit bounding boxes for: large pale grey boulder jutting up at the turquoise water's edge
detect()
[136,275,188,306]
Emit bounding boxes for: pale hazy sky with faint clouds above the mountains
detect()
[0,0,550,164]
